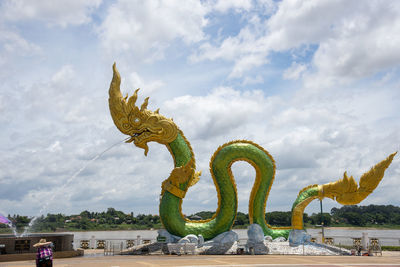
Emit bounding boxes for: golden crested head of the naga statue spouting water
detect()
[108,63,178,155]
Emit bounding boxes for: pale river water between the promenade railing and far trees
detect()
[58,227,400,249]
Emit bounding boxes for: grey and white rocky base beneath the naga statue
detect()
[123,227,350,256]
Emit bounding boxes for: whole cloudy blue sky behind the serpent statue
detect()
[0,0,400,220]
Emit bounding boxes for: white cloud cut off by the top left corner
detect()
[1,0,102,27]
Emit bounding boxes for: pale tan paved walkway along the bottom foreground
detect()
[0,253,400,267]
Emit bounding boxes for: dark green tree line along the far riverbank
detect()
[0,205,400,232]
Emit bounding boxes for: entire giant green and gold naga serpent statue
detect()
[109,63,397,240]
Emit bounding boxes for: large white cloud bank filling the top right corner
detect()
[192,1,400,87]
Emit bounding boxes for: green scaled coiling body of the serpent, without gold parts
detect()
[160,133,289,240]
